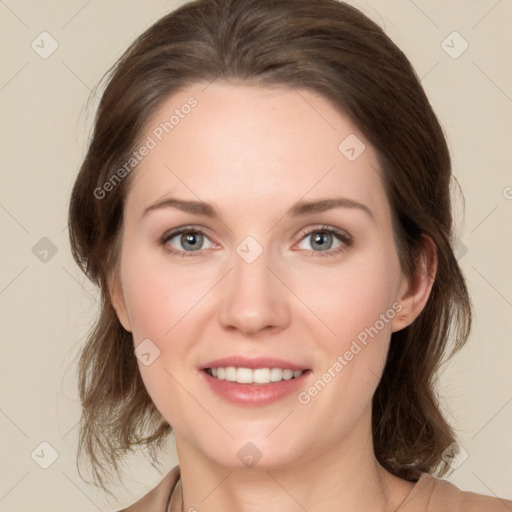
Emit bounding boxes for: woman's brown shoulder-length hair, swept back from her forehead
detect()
[69,0,471,492]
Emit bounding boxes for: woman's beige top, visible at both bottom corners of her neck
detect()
[119,466,512,512]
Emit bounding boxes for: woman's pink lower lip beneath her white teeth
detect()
[201,370,311,407]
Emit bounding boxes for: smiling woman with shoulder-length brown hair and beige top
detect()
[70,0,512,512]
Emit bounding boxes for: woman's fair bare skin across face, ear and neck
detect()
[111,82,437,512]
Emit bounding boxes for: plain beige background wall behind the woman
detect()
[0,0,512,512]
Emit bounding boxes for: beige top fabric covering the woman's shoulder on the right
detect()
[397,473,512,512]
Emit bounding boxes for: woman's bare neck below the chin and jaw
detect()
[175,408,414,512]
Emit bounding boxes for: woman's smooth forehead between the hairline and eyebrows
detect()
[127,82,386,218]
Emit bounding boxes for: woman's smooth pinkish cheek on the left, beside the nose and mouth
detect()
[121,250,205,426]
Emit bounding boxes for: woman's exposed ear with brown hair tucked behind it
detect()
[391,235,437,332]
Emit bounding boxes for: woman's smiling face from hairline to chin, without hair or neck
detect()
[112,82,407,467]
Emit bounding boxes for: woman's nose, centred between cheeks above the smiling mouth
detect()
[219,247,290,335]
